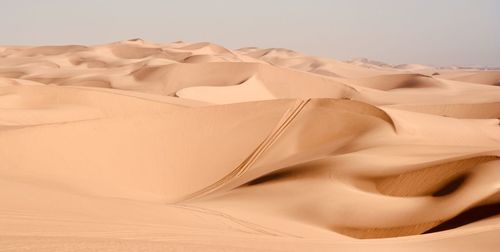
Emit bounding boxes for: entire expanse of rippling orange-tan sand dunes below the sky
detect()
[0,39,500,252]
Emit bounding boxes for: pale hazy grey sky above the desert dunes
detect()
[0,0,500,66]
